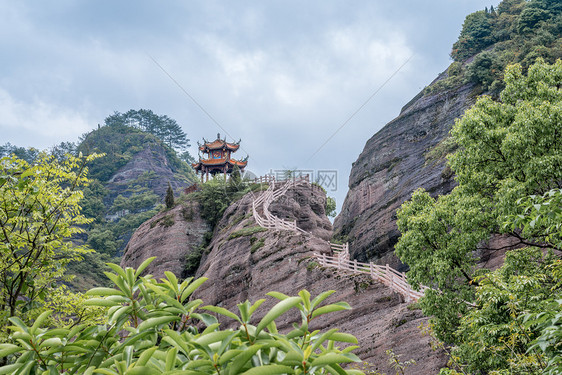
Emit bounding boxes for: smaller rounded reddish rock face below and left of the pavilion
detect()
[121,201,210,278]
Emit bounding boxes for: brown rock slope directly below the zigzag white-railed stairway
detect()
[194,187,446,374]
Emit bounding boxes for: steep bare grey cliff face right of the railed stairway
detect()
[334,78,477,270]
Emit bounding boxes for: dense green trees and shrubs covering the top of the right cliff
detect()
[425,0,562,96]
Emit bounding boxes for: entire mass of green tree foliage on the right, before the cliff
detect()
[396,60,562,374]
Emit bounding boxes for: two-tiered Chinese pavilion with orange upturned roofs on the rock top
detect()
[193,134,248,182]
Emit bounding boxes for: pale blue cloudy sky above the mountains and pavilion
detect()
[0,0,497,212]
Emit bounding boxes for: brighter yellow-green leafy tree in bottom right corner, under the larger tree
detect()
[438,189,562,375]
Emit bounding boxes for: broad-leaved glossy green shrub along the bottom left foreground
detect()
[0,258,362,375]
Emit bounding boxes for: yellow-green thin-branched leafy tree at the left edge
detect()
[0,154,98,329]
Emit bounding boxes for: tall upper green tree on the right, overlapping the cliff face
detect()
[396,60,562,342]
